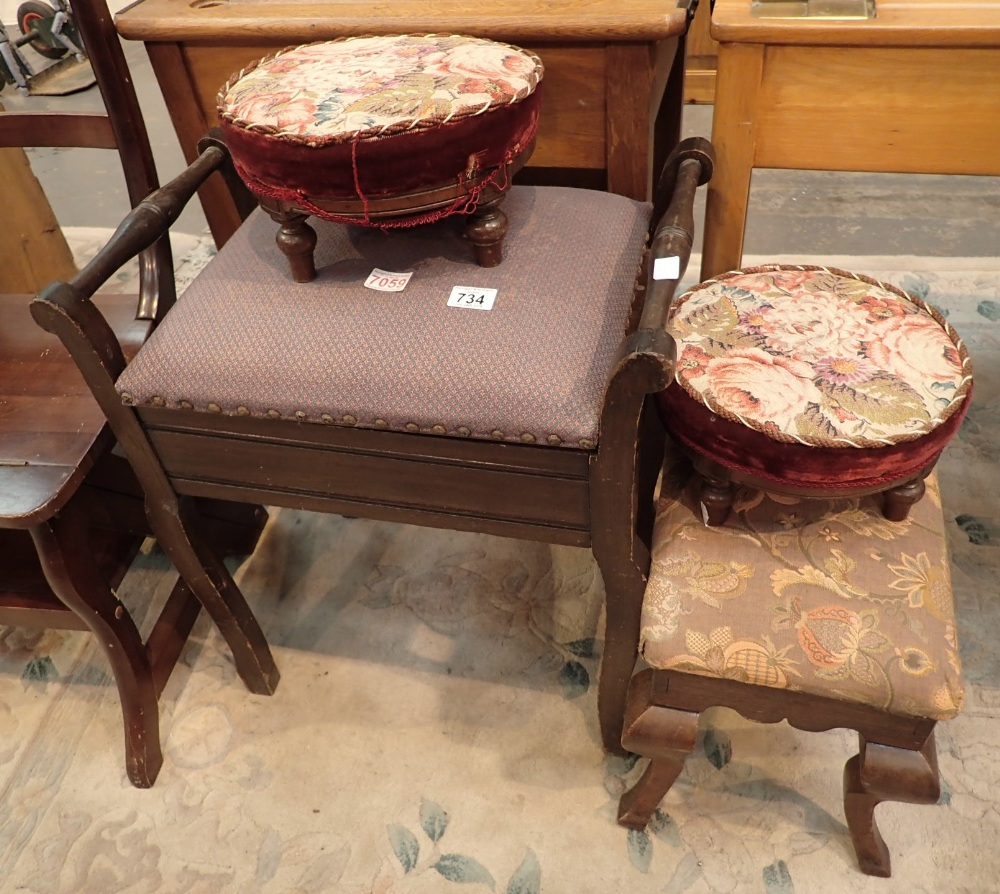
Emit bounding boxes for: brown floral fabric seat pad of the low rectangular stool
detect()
[640,473,964,720]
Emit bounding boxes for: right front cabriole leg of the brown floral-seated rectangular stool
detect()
[844,731,941,878]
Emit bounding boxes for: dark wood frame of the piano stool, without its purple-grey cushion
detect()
[32,138,713,751]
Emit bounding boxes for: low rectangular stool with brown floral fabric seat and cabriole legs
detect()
[619,473,963,876]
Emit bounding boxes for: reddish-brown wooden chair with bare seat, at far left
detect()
[0,0,277,787]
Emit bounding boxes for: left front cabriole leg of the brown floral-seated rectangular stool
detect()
[618,670,698,829]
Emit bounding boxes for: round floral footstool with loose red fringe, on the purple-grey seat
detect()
[218,35,543,282]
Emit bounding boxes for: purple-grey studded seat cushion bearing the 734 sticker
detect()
[117,186,651,449]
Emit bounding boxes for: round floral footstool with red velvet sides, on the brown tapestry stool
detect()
[660,265,972,524]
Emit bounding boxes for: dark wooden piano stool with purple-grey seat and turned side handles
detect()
[32,122,712,750]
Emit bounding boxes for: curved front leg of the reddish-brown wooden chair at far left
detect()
[31,506,163,788]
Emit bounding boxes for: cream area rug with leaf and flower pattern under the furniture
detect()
[0,248,1000,894]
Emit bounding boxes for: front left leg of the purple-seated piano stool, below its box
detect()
[146,498,280,695]
